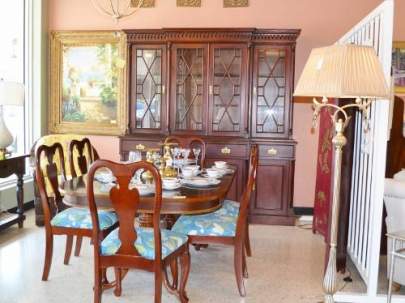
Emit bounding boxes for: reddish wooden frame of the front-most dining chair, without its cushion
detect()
[87,160,190,303]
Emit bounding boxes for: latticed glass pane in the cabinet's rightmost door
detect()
[256,49,286,133]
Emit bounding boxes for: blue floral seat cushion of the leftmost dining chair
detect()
[51,207,118,229]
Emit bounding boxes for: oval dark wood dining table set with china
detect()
[60,169,235,227]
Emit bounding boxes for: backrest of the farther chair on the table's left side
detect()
[69,138,99,177]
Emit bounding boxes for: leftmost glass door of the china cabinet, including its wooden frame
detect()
[131,46,165,132]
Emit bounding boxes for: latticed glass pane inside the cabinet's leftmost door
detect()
[136,49,162,129]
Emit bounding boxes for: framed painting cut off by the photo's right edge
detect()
[392,41,405,94]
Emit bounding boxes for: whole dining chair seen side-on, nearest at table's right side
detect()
[172,145,258,297]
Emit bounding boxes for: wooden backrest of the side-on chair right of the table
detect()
[237,144,259,232]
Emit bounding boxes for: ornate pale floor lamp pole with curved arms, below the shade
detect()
[313,97,371,303]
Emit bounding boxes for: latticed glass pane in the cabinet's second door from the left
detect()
[176,48,204,131]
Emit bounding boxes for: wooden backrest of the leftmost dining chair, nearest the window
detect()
[35,143,66,224]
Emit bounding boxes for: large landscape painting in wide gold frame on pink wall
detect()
[49,31,128,135]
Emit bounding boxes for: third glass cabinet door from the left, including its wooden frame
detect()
[209,45,247,136]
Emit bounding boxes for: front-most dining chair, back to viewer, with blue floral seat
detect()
[87,160,190,303]
